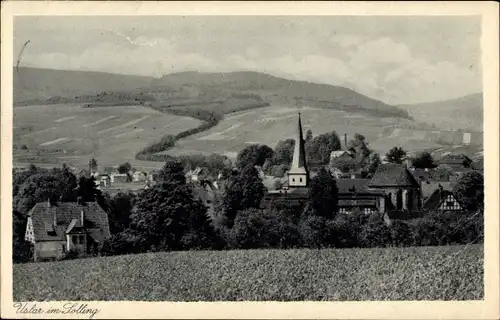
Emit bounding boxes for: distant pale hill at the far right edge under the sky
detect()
[398,93,483,132]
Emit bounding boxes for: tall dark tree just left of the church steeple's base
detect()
[222,165,266,227]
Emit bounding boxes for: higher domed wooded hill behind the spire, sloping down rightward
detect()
[148,71,408,118]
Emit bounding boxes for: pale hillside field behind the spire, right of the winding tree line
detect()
[164,105,476,158]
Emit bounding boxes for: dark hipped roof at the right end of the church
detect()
[369,163,419,187]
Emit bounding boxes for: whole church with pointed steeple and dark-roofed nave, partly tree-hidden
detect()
[264,113,421,214]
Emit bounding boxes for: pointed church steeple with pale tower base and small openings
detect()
[288,112,309,187]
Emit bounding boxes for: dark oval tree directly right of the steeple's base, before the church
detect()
[309,168,338,219]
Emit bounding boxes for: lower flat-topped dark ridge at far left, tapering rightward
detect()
[13,67,154,105]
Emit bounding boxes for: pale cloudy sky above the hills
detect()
[14,16,482,104]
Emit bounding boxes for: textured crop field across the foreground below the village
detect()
[13,245,483,301]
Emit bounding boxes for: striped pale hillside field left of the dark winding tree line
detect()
[13,104,201,168]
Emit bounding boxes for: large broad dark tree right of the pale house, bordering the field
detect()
[131,161,213,251]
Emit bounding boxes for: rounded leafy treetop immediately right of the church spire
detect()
[306,131,341,165]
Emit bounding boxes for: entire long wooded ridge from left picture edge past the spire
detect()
[14,68,408,118]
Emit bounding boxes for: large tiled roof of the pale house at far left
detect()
[28,202,111,242]
